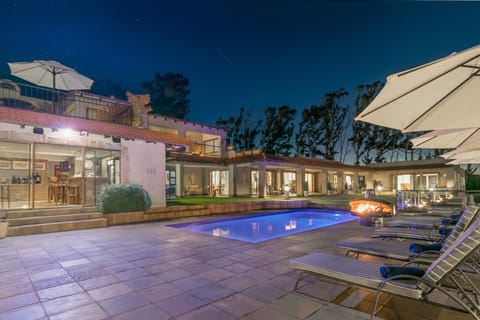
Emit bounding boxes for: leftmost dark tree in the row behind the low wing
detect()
[216,108,262,150]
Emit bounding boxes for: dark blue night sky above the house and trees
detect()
[0,0,480,124]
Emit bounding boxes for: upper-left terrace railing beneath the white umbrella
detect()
[0,80,133,125]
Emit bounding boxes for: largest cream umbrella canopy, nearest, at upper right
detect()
[355,46,480,132]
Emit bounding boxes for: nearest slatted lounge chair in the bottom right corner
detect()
[290,219,480,320]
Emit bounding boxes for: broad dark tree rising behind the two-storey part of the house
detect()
[142,72,190,119]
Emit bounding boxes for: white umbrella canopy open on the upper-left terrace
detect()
[8,60,93,91]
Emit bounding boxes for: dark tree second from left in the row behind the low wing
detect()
[260,105,297,156]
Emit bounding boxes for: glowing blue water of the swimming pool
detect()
[169,209,357,243]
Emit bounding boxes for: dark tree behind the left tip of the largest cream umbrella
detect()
[348,81,383,165]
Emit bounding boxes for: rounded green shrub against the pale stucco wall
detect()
[98,183,147,213]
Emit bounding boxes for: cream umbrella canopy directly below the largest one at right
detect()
[410,128,480,150]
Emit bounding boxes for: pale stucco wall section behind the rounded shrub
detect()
[121,140,166,207]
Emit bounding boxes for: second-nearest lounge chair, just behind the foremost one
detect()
[336,206,480,263]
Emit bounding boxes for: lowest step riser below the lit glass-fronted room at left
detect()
[8,218,108,236]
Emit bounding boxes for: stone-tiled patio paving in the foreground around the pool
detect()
[0,214,470,320]
